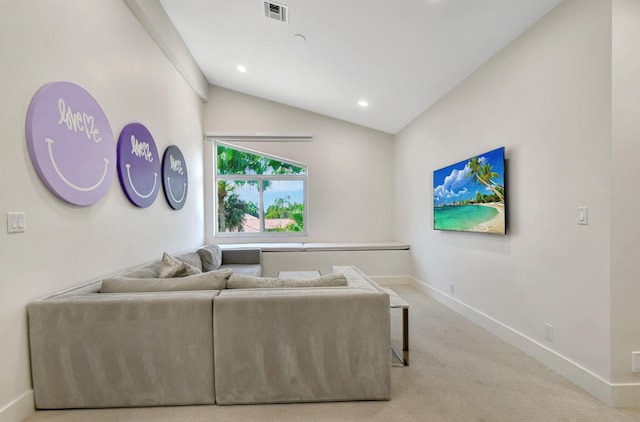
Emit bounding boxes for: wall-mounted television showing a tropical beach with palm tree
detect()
[433,147,506,234]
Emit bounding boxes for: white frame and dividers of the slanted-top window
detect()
[211,139,309,238]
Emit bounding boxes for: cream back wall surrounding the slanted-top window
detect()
[204,86,393,243]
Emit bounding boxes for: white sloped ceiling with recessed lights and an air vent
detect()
[160,0,560,134]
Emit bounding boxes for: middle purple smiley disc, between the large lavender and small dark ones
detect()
[118,123,161,208]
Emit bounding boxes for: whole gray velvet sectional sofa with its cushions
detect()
[27,246,391,409]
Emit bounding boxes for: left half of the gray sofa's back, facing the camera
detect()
[27,291,218,409]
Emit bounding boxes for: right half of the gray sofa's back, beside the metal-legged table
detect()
[213,287,393,404]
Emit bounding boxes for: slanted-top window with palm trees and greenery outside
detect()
[215,142,307,235]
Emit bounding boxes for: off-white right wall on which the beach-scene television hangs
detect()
[395,0,624,401]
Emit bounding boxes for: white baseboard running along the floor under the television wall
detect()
[405,277,640,408]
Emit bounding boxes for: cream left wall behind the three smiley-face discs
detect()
[0,0,204,421]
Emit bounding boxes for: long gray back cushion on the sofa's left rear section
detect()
[100,270,231,293]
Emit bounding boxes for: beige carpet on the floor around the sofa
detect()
[22,286,640,422]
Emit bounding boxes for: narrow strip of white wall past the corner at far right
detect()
[610,0,640,405]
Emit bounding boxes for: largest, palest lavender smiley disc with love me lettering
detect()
[26,82,116,205]
